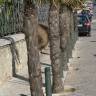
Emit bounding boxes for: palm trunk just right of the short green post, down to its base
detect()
[49,4,64,93]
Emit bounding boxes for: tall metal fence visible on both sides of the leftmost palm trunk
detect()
[0,0,49,37]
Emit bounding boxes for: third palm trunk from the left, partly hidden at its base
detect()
[60,4,69,71]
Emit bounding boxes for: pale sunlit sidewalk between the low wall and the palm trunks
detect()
[0,49,51,96]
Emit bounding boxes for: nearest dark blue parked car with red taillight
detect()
[77,14,91,36]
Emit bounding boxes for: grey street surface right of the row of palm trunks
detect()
[65,20,96,96]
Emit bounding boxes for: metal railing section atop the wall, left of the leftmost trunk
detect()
[0,0,23,37]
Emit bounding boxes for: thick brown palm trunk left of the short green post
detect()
[24,0,43,96]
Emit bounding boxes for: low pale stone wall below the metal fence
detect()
[0,34,27,84]
